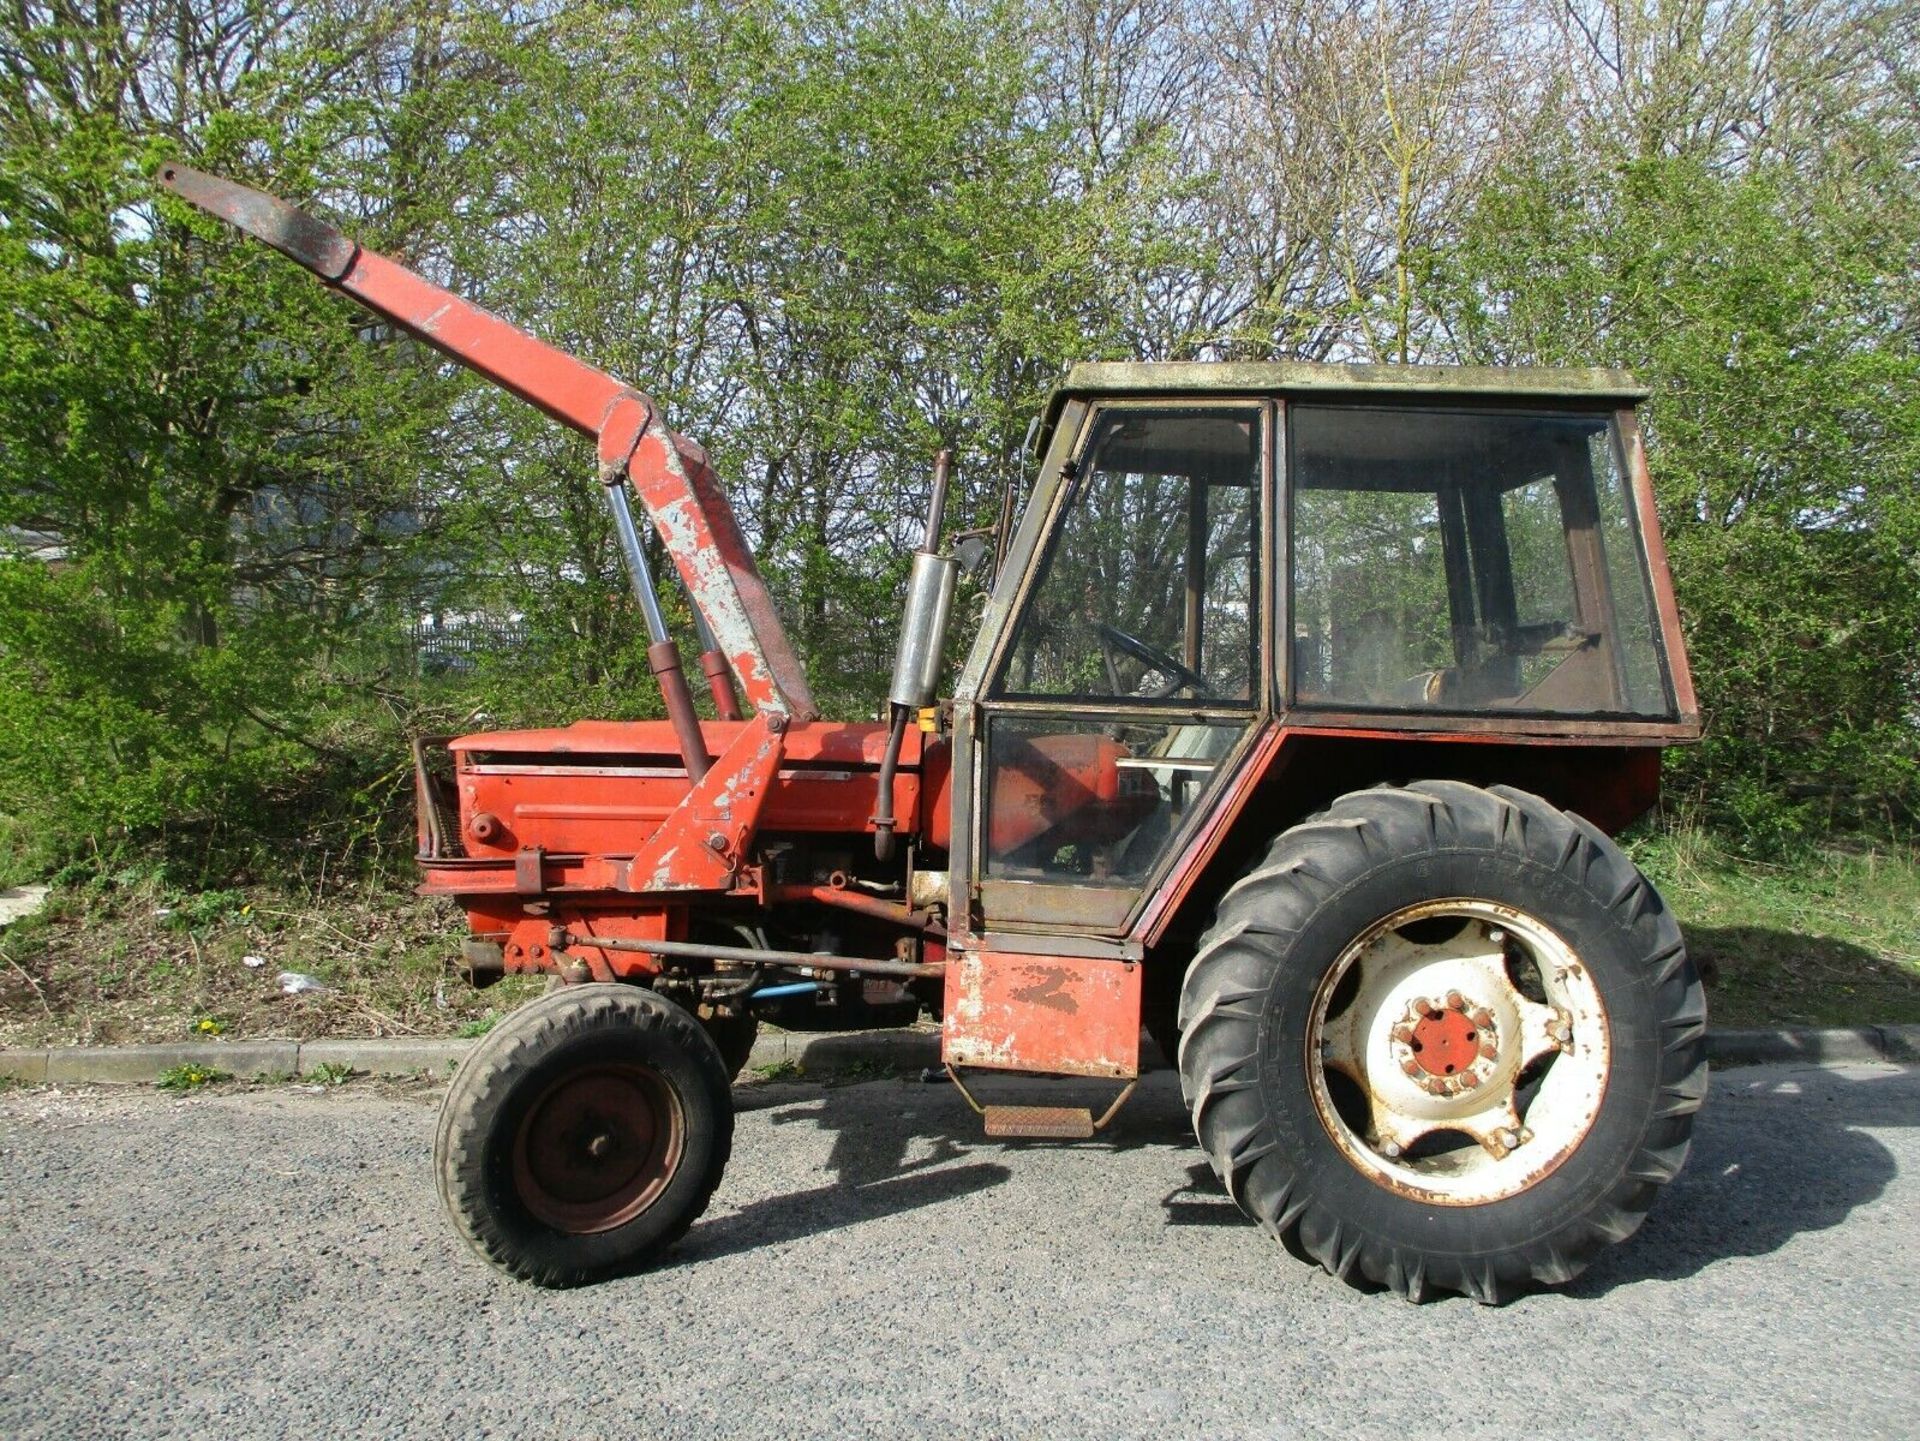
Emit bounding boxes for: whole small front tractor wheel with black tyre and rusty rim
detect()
[434,984,733,1286]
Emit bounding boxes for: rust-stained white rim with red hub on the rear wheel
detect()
[1306,898,1611,1205]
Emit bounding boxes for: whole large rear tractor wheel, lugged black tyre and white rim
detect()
[1181,781,1707,1303]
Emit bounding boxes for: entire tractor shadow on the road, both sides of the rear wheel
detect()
[683,1055,1920,1299]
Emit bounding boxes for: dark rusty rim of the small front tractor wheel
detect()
[513,1063,685,1236]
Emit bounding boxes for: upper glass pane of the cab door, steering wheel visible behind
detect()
[995,409,1260,704]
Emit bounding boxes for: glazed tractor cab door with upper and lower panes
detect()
[956,401,1273,936]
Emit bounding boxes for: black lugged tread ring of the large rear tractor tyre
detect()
[1179,781,1707,1303]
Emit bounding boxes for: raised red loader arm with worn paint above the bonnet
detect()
[157,163,818,720]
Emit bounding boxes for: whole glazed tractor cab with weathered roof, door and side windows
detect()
[936,365,1695,1069]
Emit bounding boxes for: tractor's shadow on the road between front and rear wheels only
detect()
[662,1069,1190,1266]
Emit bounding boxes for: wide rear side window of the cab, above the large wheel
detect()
[1288,405,1672,716]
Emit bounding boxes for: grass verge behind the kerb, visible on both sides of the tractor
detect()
[0,831,1920,1043]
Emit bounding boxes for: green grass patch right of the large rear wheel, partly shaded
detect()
[1630,831,1920,1027]
